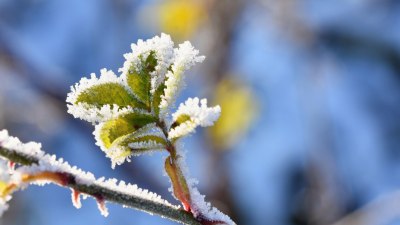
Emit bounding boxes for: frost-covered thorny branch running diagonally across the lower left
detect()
[0,131,200,225]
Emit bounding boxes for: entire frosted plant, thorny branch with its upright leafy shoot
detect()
[0,34,235,225]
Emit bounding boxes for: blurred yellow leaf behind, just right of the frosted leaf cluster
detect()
[209,78,258,151]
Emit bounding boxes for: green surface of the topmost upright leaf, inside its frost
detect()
[127,51,157,108]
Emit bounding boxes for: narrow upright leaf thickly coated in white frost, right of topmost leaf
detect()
[159,41,205,116]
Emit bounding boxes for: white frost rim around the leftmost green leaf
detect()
[67,69,132,123]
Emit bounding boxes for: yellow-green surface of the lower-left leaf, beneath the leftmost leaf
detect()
[100,112,156,149]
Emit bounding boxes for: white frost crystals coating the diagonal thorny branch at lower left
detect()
[0,130,179,218]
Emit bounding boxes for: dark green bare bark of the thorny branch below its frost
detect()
[0,146,201,225]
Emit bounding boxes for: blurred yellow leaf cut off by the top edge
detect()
[158,0,205,40]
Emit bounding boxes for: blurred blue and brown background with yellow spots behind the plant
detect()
[0,0,400,225]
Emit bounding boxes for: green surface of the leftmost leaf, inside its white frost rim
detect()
[75,83,143,108]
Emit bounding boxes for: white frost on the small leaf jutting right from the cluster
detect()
[168,98,221,139]
